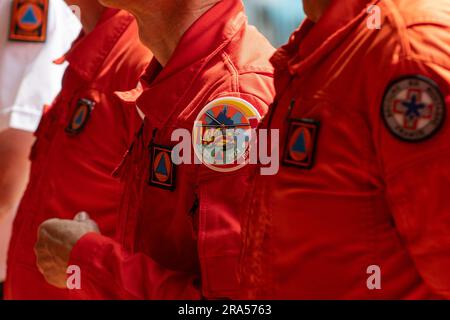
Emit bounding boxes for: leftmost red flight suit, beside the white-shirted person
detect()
[5,9,151,299]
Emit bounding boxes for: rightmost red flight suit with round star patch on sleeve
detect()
[242,0,450,299]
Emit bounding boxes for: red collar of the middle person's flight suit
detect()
[134,0,247,128]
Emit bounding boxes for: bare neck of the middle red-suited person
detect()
[125,0,221,66]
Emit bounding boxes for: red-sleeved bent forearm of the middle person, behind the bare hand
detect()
[69,233,201,300]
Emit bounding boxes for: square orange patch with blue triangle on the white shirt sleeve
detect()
[9,0,49,42]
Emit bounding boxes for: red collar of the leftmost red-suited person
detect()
[55,9,133,82]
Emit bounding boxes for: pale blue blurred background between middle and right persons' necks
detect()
[243,0,305,47]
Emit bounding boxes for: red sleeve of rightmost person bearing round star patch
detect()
[372,56,450,298]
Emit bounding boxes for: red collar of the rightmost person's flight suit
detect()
[271,0,379,75]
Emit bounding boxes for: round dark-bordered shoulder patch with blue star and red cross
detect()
[381,76,446,142]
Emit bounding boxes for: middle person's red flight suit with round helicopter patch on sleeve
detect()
[70,0,274,299]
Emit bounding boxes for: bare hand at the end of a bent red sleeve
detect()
[34,212,99,288]
